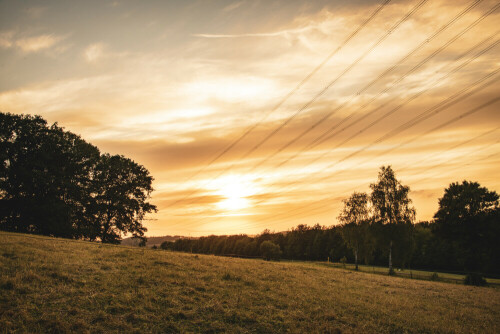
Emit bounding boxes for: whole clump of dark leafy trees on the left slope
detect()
[0,113,156,243]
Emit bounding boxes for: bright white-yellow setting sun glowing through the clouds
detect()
[213,175,257,211]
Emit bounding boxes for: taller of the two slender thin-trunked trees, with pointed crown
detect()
[370,166,415,273]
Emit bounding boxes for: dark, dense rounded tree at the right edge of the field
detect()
[434,181,500,270]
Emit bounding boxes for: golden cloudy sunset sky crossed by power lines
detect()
[0,0,500,236]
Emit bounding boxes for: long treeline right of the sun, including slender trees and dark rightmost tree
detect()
[161,167,500,274]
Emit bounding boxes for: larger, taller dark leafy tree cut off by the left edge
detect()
[0,113,99,238]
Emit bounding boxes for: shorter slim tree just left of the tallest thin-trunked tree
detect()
[338,192,370,270]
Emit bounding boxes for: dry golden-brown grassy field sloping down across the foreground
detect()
[0,232,500,333]
